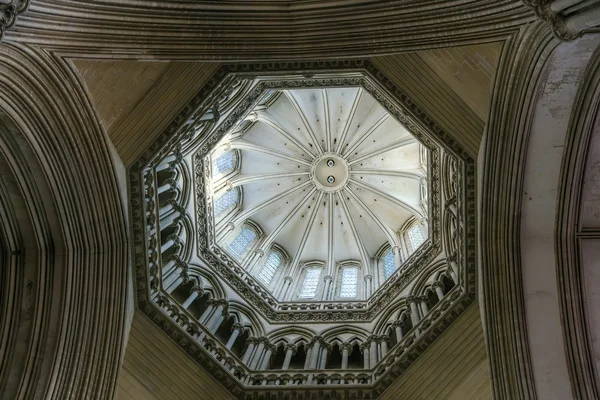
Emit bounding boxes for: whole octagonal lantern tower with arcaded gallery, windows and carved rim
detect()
[130,61,475,398]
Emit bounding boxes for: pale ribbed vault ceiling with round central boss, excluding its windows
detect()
[212,87,427,300]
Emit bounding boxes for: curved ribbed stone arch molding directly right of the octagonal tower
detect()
[479,22,558,400]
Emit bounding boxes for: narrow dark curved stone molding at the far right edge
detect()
[555,39,600,400]
